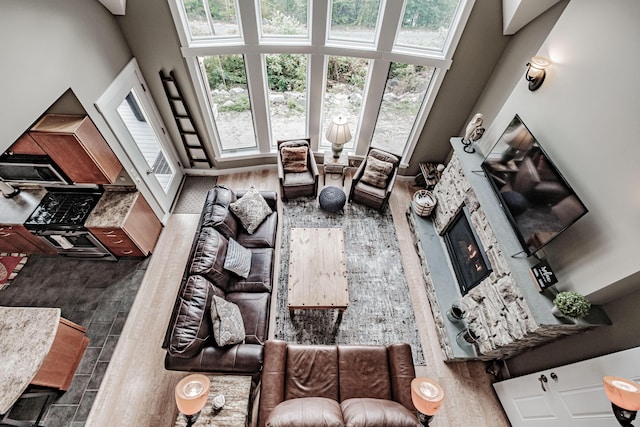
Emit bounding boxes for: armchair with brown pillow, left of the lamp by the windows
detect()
[278,138,318,200]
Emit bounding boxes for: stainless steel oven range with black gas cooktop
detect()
[24,188,117,261]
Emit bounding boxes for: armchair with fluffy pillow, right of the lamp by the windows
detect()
[349,147,400,212]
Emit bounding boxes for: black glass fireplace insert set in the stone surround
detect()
[443,206,492,295]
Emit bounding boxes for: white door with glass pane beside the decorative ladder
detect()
[96,58,183,216]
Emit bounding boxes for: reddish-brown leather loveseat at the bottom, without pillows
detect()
[258,341,421,427]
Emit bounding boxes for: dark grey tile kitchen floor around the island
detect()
[0,255,149,427]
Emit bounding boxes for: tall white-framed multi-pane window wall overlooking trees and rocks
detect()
[169,0,474,161]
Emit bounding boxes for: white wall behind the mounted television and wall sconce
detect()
[482,0,640,303]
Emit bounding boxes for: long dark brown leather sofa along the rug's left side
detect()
[162,186,278,377]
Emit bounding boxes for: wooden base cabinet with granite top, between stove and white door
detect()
[84,191,162,256]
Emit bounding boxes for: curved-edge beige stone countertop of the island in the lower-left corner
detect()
[0,307,60,414]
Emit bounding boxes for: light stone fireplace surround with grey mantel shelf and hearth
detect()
[407,138,610,361]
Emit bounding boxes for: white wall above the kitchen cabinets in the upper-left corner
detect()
[0,0,131,152]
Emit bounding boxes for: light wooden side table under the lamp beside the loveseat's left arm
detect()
[174,375,251,427]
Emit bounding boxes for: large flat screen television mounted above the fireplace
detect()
[482,115,587,255]
